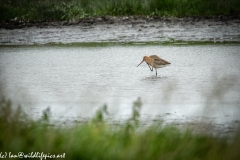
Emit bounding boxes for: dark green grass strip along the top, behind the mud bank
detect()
[0,0,240,20]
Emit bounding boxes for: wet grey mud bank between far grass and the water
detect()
[0,16,240,45]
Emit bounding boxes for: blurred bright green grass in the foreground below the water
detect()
[0,98,240,160]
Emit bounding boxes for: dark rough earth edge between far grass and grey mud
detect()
[0,15,240,29]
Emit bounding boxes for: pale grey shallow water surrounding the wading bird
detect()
[0,44,240,123]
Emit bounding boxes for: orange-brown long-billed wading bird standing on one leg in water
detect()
[137,55,171,76]
